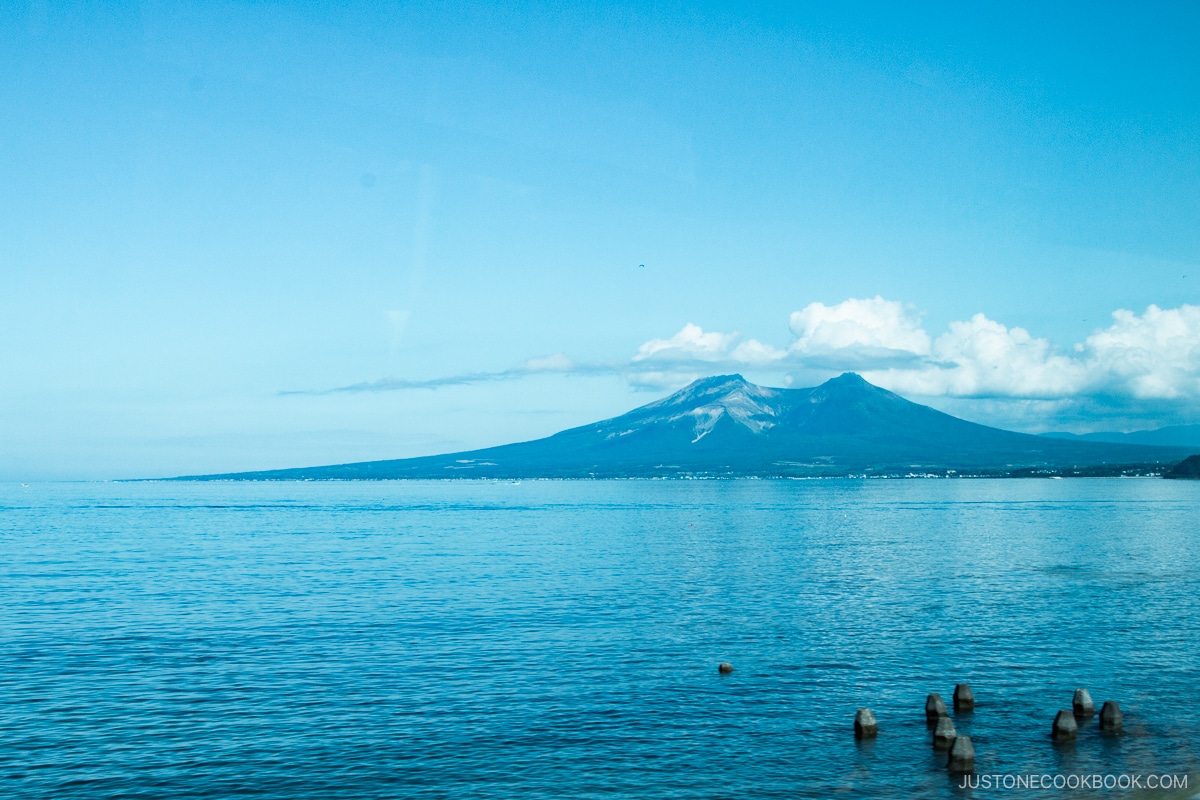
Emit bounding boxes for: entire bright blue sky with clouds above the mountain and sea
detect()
[0,0,1200,480]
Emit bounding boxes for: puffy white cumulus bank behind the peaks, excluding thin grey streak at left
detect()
[634,296,1200,399]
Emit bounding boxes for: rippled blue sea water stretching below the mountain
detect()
[0,480,1200,799]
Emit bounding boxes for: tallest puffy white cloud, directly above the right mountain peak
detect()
[790,295,929,355]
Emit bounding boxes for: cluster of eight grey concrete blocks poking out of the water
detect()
[854,684,1122,772]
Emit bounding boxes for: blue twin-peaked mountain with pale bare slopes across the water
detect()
[180,373,1188,480]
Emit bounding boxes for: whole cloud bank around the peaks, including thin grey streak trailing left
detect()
[295,296,1200,429]
